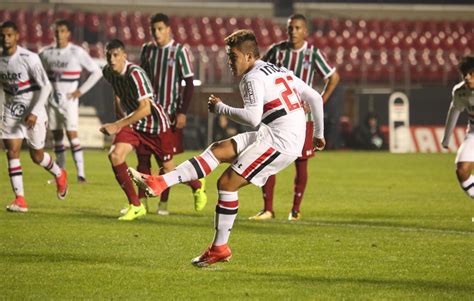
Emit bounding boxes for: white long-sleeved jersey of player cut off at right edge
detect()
[442,81,474,146]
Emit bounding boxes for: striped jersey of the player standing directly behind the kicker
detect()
[263,41,336,121]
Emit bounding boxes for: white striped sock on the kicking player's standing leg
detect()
[212,190,239,246]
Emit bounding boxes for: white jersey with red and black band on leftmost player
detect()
[0,46,49,120]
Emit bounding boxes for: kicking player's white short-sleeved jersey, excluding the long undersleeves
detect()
[239,60,306,156]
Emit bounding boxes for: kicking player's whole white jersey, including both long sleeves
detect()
[216,60,324,157]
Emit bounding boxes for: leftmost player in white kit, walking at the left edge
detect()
[0,21,68,212]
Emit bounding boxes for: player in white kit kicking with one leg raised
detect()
[129,30,325,267]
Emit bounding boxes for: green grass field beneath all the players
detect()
[0,151,474,300]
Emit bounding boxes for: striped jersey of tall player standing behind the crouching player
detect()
[140,40,194,116]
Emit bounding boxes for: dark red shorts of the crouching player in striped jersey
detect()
[113,127,173,162]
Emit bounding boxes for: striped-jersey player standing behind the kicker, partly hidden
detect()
[250,14,339,221]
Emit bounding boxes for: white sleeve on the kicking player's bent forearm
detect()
[216,102,263,127]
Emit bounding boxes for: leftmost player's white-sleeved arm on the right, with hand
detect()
[25,56,52,128]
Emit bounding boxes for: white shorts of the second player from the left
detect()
[48,99,79,131]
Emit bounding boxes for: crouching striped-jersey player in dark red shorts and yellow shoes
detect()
[100,39,173,221]
